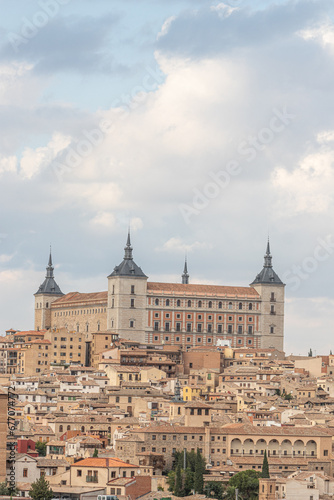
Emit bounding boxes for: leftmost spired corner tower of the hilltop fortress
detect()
[34,248,64,330]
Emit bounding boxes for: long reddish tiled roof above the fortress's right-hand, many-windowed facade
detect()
[147,283,260,298]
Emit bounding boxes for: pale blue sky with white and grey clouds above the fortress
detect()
[0,0,334,354]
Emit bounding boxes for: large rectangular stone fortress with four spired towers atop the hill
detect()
[35,234,284,350]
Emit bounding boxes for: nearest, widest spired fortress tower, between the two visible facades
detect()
[107,231,147,342]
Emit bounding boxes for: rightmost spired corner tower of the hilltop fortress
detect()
[250,239,285,351]
